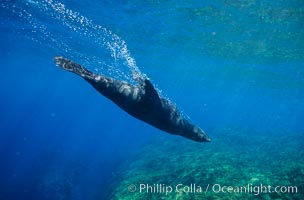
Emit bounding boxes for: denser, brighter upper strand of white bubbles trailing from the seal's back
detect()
[37,0,146,81]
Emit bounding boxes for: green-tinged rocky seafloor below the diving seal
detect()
[111,129,304,200]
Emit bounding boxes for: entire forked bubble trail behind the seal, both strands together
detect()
[1,0,147,82]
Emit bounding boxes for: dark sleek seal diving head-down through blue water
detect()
[54,57,211,142]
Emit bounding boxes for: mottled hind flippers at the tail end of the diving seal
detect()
[54,56,95,79]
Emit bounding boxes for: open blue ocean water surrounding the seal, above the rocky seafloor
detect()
[0,0,304,199]
